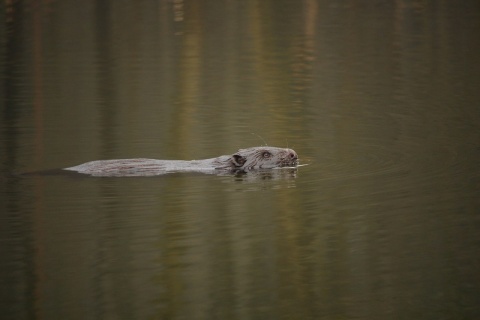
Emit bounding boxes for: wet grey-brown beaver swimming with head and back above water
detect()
[63,146,298,177]
